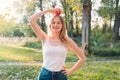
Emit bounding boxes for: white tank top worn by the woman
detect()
[43,39,67,71]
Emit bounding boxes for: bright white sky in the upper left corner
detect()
[0,0,22,23]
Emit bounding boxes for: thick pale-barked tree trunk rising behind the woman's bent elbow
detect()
[82,0,91,53]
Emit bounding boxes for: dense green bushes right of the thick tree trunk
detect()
[90,26,120,56]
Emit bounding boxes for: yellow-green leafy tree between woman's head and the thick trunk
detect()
[60,0,81,38]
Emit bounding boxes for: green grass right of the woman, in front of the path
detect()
[69,62,120,80]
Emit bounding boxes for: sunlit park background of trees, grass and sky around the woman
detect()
[0,0,120,80]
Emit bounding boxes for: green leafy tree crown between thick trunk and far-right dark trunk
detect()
[98,0,115,31]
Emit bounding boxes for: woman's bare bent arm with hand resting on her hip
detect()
[65,38,86,74]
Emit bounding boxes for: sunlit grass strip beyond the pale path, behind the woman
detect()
[0,44,120,62]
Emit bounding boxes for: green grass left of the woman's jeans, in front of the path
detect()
[0,66,40,80]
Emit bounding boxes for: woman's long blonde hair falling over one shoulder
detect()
[49,15,68,43]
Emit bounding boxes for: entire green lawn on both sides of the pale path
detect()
[0,44,120,80]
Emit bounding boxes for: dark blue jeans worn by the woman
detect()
[38,67,67,80]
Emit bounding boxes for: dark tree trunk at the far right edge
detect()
[113,0,120,43]
